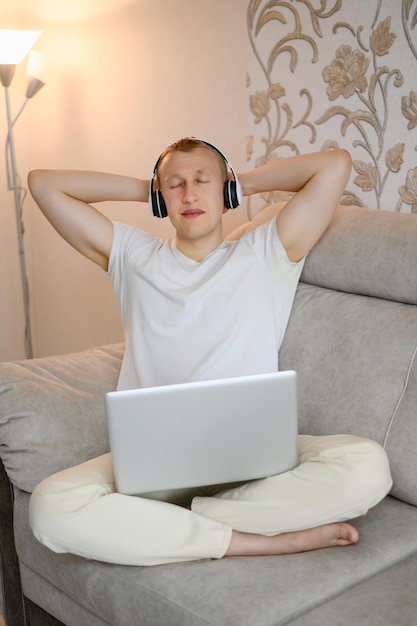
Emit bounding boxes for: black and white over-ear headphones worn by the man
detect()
[149,137,242,217]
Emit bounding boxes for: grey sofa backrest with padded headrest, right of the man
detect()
[280,207,417,505]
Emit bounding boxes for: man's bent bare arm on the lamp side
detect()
[28,170,149,270]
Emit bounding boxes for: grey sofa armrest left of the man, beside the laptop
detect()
[0,344,124,492]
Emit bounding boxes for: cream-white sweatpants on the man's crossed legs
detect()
[29,435,392,565]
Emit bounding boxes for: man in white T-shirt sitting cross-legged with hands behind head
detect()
[29,138,391,565]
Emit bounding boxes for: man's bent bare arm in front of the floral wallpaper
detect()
[239,150,352,261]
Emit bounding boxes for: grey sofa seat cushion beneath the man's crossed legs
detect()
[16,494,417,626]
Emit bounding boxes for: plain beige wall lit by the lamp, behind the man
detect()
[0,0,247,360]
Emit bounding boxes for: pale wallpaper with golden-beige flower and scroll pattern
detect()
[247,0,417,216]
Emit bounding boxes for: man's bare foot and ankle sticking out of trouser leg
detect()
[225,522,359,556]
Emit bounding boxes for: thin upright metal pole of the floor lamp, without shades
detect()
[0,65,33,359]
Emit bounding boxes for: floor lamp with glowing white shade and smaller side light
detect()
[0,30,43,359]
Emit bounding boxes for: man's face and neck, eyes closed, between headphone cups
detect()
[158,147,226,255]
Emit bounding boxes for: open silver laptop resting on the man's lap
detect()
[105,371,297,495]
